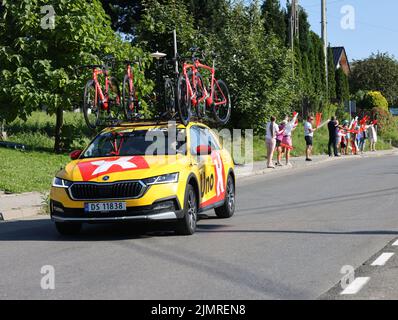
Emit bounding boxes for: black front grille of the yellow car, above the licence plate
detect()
[70,181,144,200]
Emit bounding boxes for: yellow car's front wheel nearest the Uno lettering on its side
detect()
[176,184,198,236]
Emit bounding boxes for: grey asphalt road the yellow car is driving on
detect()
[0,156,398,299]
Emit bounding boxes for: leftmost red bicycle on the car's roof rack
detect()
[79,57,122,130]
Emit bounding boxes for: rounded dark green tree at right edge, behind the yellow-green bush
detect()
[350,53,398,105]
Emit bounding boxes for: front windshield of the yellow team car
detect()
[81,128,186,158]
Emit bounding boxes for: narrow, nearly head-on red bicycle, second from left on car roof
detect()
[122,60,141,120]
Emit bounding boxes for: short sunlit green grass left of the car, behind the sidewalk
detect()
[0,148,69,193]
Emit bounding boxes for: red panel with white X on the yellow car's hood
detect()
[77,156,149,181]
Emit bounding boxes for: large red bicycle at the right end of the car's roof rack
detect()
[177,48,231,125]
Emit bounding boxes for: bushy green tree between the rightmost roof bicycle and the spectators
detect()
[213,1,296,133]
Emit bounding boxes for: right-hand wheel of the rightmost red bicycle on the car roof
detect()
[213,80,231,124]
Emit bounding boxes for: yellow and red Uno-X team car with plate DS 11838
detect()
[50,122,235,235]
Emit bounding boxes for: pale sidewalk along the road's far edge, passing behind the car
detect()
[0,149,398,221]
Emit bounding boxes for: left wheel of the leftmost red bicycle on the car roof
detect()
[83,80,101,130]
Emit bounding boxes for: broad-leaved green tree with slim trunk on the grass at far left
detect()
[0,0,150,152]
